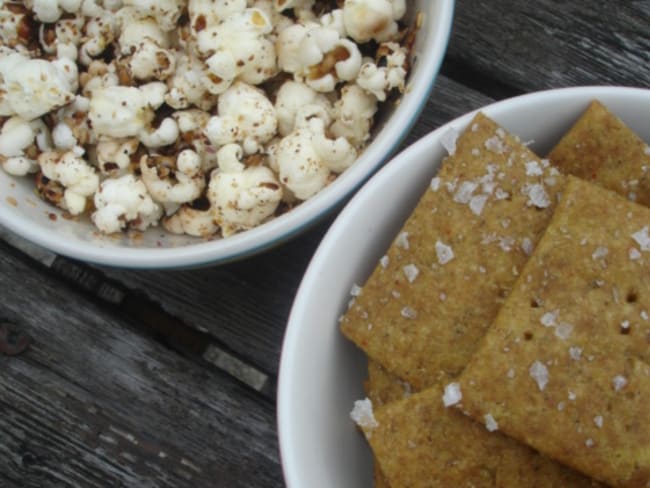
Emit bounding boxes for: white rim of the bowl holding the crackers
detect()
[277,85,650,488]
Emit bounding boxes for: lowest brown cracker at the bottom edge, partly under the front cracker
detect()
[356,382,601,488]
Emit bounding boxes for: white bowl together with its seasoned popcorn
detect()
[0,0,454,268]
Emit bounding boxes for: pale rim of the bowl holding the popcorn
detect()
[0,0,455,269]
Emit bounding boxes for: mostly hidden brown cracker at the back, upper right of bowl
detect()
[549,101,650,206]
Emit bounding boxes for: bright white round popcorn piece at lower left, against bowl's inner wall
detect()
[91,175,162,234]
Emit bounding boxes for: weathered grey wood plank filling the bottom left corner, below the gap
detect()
[0,243,282,487]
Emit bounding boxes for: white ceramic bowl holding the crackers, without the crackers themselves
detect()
[278,87,650,488]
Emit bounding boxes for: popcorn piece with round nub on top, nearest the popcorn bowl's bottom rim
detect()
[208,144,282,236]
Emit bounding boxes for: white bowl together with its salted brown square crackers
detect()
[278,87,650,488]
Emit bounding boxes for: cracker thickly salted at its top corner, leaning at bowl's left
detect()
[341,113,564,389]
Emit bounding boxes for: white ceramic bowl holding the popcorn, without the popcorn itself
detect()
[0,0,454,268]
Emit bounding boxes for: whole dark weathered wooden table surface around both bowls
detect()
[0,0,650,487]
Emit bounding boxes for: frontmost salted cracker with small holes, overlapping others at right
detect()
[460,178,650,487]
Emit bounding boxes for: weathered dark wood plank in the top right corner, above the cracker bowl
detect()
[447,0,650,94]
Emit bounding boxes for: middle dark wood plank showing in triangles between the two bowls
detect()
[86,77,492,375]
